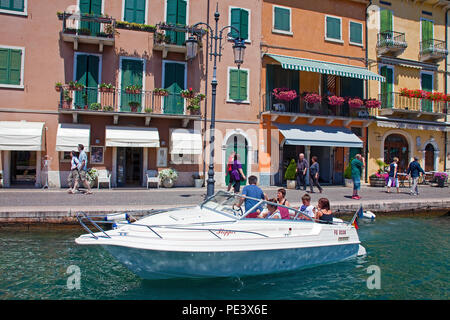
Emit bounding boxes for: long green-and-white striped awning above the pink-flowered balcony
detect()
[266,54,385,82]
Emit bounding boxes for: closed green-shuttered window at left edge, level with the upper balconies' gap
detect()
[0,47,24,88]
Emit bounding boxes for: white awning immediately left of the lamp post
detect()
[170,129,202,154]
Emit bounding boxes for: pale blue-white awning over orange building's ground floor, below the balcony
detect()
[275,123,363,148]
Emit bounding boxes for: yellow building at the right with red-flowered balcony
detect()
[367,0,450,175]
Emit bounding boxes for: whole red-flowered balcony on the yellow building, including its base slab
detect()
[378,92,447,120]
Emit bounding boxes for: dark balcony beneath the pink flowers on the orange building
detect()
[262,93,372,124]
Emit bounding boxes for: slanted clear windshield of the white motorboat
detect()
[201,191,312,220]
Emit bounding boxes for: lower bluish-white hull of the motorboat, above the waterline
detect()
[103,244,359,279]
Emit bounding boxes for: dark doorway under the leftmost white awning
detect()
[11,151,36,185]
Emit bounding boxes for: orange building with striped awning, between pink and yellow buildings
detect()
[259,0,384,184]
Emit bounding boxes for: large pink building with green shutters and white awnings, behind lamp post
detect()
[0,0,261,187]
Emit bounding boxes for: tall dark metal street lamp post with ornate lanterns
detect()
[186,4,245,197]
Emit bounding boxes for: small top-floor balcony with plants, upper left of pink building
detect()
[58,12,116,52]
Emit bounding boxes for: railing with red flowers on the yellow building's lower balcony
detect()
[379,92,447,114]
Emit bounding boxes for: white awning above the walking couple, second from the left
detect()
[56,123,91,151]
